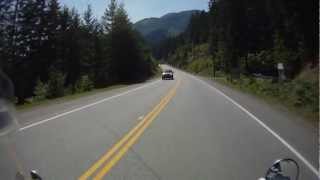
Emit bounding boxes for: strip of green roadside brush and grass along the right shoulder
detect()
[189,68,319,123]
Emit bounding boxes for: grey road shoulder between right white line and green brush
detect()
[198,77,319,168]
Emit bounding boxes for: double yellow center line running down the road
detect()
[79,80,181,180]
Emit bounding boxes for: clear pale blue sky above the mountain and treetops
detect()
[60,0,208,22]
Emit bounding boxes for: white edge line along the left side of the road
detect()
[19,80,160,131]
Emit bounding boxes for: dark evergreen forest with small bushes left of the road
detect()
[0,0,156,104]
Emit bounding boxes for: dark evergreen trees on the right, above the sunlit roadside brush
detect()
[155,0,319,78]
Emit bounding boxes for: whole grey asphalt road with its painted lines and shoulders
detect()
[0,67,319,180]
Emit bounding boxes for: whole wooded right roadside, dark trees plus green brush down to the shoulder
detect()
[153,0,319,119]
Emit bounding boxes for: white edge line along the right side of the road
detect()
[188,74,319,177]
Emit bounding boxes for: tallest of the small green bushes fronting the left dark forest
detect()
[48,71,66,98]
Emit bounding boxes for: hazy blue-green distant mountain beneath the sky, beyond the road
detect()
[134,10,199,45]
